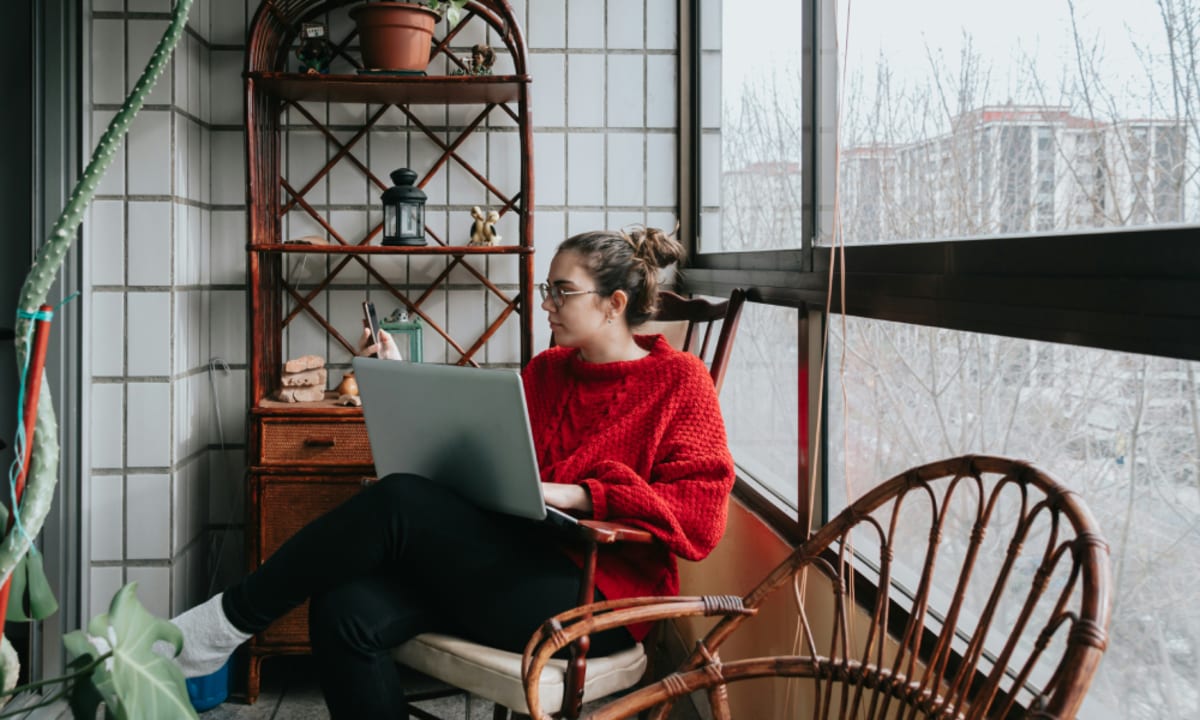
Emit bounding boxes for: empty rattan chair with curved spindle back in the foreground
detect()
[523,456,1111,720]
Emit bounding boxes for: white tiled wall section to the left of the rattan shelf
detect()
[83,0,225,616]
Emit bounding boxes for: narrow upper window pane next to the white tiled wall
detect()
[698,0,804,252]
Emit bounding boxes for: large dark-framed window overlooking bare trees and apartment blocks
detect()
[685,0,1200,718]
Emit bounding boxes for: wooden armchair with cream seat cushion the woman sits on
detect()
[392,289,745,720]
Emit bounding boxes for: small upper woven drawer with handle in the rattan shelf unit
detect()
[259,418,374,466]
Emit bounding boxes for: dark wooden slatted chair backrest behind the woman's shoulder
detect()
[646,289,745,392]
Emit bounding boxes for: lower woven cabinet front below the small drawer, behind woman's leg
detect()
[258,475,364,646]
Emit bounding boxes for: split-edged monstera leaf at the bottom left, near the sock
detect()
[65,582,197,720]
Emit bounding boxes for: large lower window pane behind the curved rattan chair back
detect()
[827,318,1200,719]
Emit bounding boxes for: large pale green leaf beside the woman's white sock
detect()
[89,582,197,720]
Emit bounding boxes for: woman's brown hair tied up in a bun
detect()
[558,226,686,328]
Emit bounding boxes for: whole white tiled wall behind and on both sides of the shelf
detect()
[83,0,678,614]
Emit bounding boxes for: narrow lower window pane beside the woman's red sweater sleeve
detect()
[721,304,800,509]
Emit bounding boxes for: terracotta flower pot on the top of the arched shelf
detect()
[350,0,438,72]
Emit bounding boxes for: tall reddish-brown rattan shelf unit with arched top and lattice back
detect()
[241,0,536,702]
